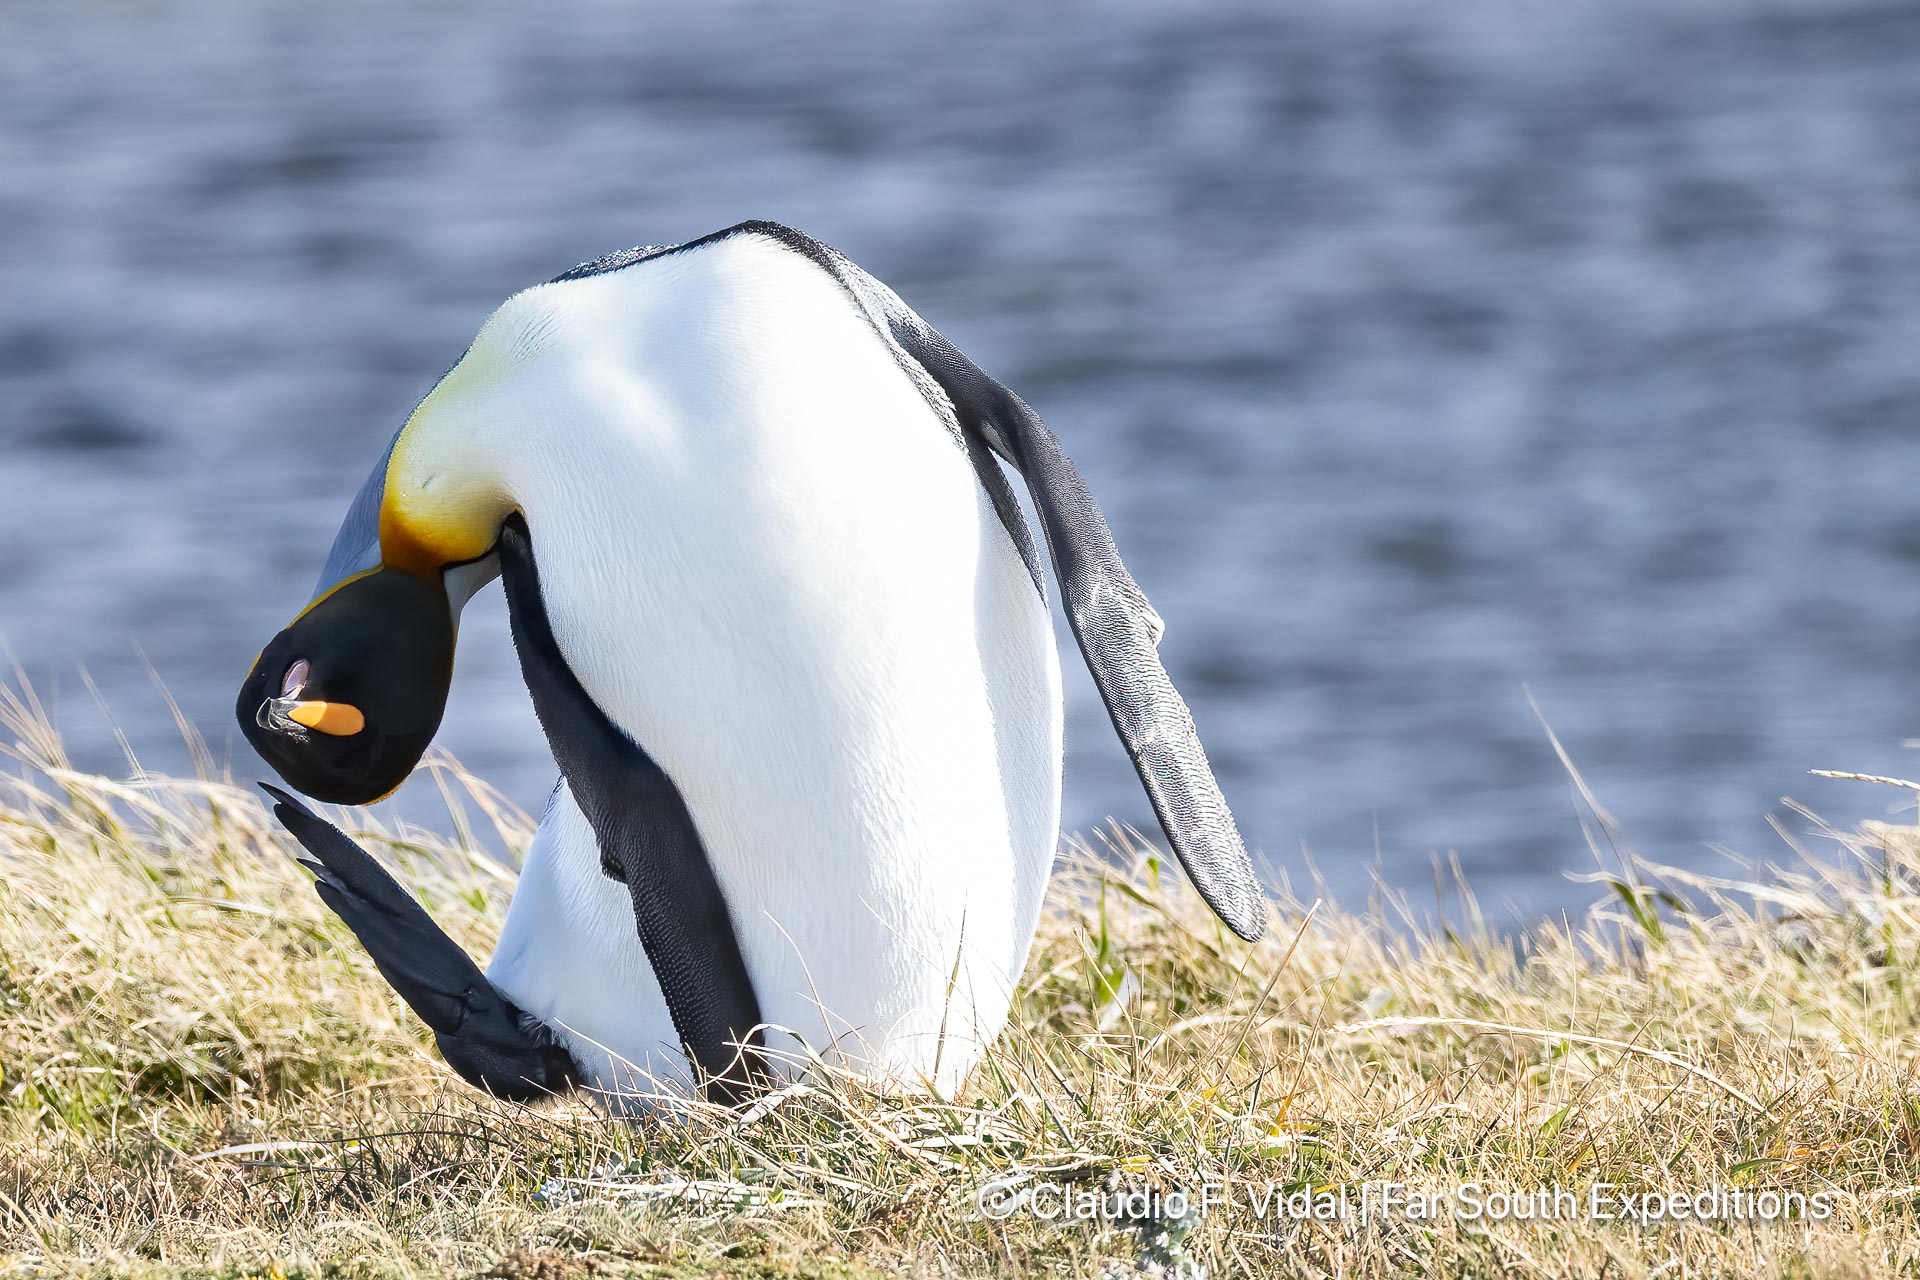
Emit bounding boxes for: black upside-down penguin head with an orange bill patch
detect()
[234,566,453,804]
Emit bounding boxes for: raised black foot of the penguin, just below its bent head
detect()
[261,783,580,1102]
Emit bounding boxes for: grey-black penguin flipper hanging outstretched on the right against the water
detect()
[887,316,1267,942]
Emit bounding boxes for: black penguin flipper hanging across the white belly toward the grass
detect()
[499,516,764,1103]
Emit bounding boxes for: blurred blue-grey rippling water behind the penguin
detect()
[0,0,1920,910]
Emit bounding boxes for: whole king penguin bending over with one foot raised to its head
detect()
[236,223,1267,1102]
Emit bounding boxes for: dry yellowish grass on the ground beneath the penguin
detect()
[0,687,1920,1280]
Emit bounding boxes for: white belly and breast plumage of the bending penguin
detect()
[405,234,1062,1088]
